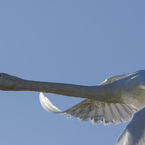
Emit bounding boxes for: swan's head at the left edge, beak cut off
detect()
[0,73,21,91]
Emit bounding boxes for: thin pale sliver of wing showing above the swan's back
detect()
[100,73,130,85]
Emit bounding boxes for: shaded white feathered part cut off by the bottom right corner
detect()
[116,108,145,145]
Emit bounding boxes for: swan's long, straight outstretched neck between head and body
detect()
[15,80,101,98]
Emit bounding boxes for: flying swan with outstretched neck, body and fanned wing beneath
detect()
[0,70,145,125]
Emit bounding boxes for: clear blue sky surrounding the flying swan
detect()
[0,0,145,145]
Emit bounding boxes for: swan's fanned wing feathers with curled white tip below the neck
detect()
[39,93,137,125]
